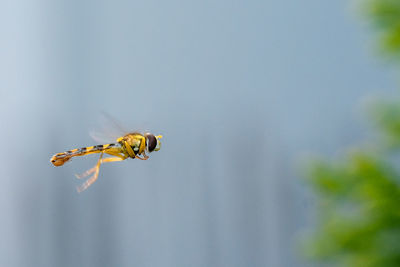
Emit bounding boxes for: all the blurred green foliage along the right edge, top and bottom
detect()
[307,0,400,267]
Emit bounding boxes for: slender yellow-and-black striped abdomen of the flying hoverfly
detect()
[50,144,119,166]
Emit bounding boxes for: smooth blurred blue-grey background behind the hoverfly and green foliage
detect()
[0,0,396,267]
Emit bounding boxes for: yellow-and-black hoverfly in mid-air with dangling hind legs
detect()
[50,132,162,192]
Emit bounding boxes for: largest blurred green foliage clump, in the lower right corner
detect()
[309,152,400,266]
